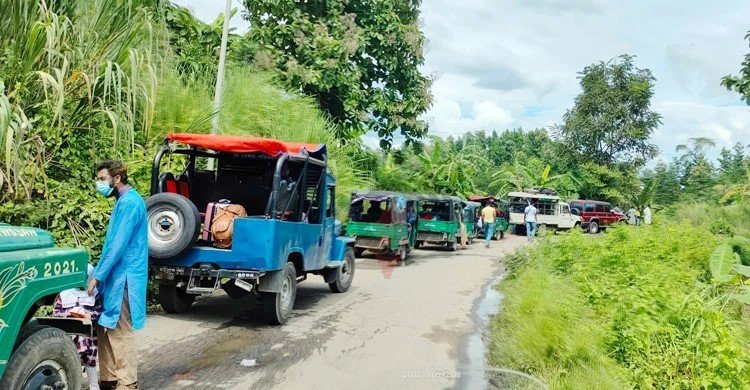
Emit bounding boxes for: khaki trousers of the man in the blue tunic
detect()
[96,289,138,389]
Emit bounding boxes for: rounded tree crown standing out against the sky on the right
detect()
[557,55,661,167]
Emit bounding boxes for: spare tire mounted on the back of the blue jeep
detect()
[146,192,201,259]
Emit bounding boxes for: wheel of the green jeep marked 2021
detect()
[0,328,83,389]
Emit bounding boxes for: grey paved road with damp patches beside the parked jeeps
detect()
[137,236,524,389]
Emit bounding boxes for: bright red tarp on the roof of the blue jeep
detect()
[167,133,325,157]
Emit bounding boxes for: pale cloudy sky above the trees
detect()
[176,0,750,159]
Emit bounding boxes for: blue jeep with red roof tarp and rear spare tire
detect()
[147,133,354,324]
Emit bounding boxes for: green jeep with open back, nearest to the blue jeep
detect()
[346,191,417,264]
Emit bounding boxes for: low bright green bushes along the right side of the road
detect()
[491,223,750,388]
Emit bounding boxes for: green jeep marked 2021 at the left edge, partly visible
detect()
[0,223,92,389]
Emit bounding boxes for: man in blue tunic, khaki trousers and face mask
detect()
[88,161,148,390]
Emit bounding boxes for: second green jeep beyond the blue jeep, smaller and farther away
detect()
[416,195,463,251]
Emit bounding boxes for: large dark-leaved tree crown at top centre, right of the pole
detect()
[240,0,432,147]
